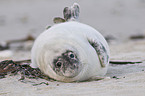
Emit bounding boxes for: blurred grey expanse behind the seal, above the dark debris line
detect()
[0,0,145,41]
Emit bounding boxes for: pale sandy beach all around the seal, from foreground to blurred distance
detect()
[0,0,145,96]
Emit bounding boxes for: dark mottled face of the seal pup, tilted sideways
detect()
[53,50,80,78]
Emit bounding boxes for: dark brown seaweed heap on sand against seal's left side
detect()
[0,60,49,80]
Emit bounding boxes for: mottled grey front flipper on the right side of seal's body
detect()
[89,40,109,67]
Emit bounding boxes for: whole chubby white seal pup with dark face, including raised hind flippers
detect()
[31,3,109,82]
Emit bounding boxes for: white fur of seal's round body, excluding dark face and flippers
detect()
[31,21,109,82]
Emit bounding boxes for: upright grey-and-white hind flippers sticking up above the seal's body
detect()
[63,3,80,21]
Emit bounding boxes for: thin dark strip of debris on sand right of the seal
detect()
[109,60,142,65]
